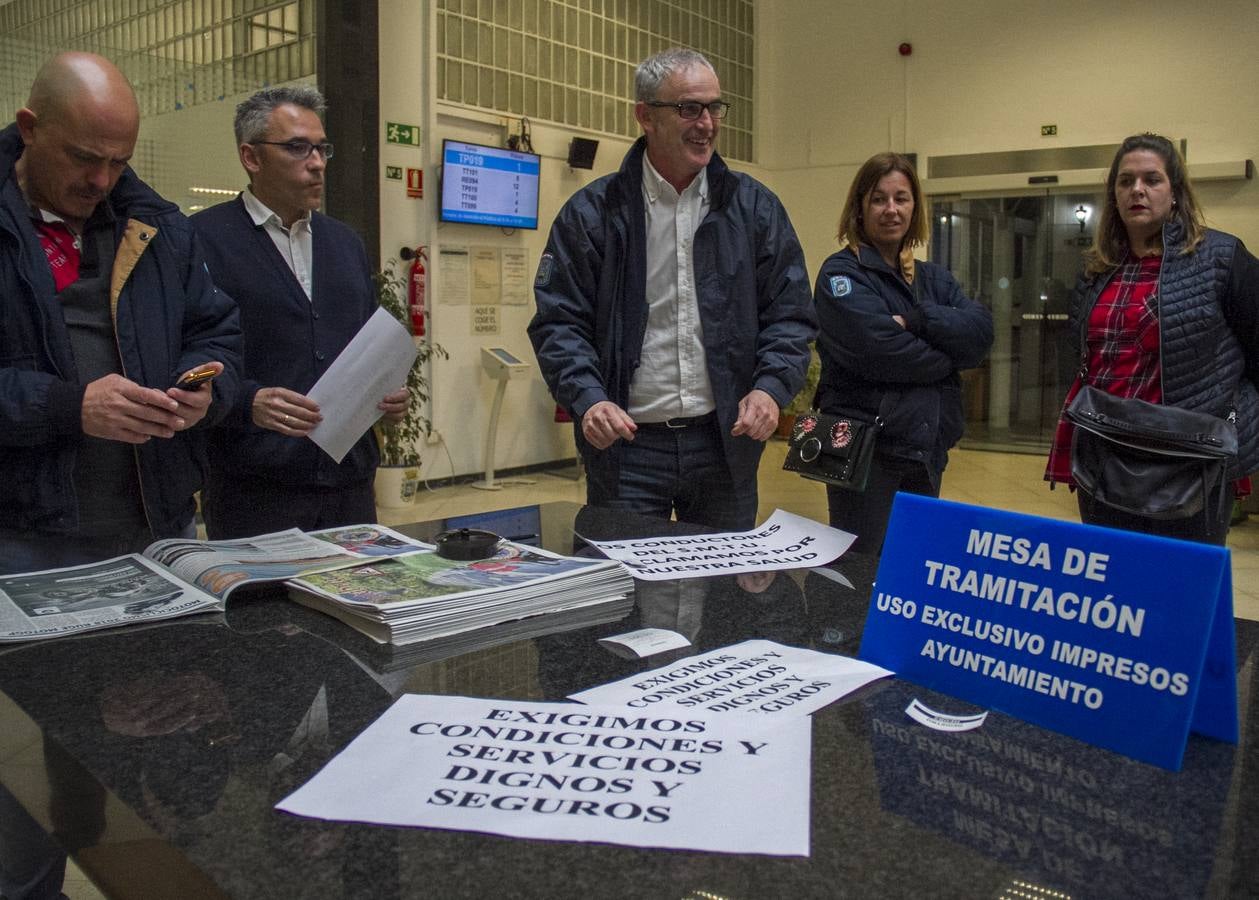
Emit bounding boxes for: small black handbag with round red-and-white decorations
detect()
[783,412,880,491]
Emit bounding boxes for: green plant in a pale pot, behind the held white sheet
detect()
[373,259,449,509]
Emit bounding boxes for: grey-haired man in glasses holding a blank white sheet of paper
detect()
[193,87,409,537]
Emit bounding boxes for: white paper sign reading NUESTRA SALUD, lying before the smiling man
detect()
[585,510,857,582]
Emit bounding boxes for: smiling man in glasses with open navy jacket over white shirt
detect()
[529,49,816,530]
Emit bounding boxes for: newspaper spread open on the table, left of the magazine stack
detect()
[0,525,432,641]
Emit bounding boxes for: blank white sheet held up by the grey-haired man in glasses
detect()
[307,310,415,462]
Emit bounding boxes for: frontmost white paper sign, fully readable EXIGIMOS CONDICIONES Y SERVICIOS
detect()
[276,694,812,856]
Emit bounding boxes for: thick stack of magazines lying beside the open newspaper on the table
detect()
[287,541,633,644]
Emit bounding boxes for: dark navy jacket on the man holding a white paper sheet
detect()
[191,196,380,487]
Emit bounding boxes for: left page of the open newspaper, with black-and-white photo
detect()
[0,554,223,641]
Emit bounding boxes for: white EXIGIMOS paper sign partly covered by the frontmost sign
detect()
[569,641,893,721]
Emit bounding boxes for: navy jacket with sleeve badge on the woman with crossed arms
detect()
[813,244,992,480]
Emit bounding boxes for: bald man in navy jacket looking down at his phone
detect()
[0,53,240,900]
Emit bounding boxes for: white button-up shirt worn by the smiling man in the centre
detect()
[626,154,716,422]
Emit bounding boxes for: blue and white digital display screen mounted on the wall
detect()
[441,140,541,229]
